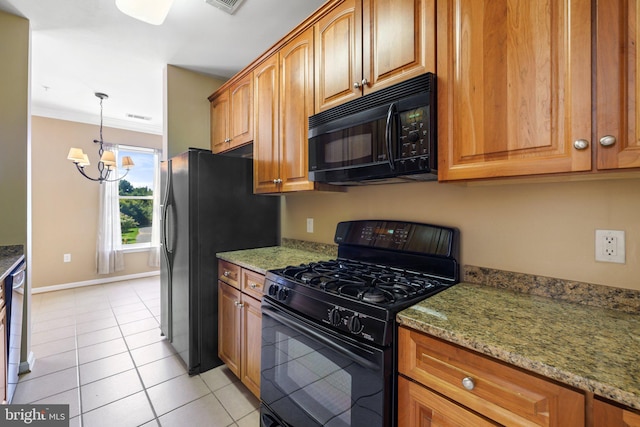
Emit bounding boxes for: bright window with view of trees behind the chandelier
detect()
[118,145,160,249]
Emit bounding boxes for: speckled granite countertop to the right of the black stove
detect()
[397,283,640,409]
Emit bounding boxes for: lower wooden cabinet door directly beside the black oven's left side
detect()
[241,295,262,398]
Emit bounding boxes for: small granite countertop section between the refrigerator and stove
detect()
[216,246,335,274]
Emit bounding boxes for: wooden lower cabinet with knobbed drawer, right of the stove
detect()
[398,327,585,427]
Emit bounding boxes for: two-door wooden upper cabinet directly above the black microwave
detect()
[314,0,435,113]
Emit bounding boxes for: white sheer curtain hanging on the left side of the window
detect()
[96,147,124,274]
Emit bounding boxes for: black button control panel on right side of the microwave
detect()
[399,106,431,159]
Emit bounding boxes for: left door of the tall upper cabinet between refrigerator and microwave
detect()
[253,53,280,193]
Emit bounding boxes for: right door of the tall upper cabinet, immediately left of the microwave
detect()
[280,27,313,192]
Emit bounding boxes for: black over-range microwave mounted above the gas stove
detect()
[309,73,438,185]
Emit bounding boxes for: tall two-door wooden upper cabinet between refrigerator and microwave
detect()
[253,28,314,193]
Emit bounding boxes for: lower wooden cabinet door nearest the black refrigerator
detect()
[218,281,242,377]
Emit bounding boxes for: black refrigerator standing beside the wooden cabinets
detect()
[160,148,280,375]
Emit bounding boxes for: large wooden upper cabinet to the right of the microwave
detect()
[437,0,640,181]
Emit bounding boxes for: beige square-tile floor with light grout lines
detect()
[13,276,259,427]
